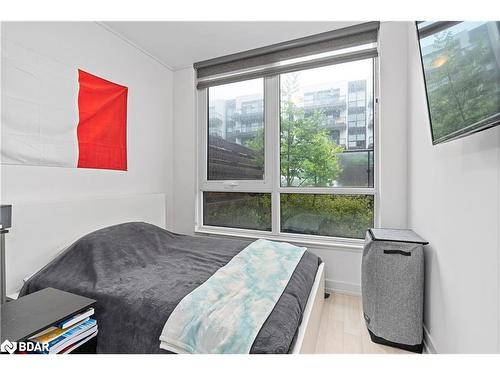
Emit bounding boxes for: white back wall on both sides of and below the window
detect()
[174,22,408,294]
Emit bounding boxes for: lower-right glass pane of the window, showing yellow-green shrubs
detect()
[280,194,374,238]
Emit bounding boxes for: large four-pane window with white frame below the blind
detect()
[198,58,377,239]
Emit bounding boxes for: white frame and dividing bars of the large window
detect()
[195,57,381,250]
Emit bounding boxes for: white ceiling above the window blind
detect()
[101,21,359,69]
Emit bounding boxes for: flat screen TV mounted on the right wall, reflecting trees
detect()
[416,21,500,144]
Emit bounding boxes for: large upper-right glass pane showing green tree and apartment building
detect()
[280,59,373,187]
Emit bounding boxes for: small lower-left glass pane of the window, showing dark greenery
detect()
[203,192,271,231]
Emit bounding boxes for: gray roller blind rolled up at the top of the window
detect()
[194,22,380,88]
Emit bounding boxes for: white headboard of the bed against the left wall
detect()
[5,194,166,294]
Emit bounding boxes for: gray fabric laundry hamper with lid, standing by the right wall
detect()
[361,229,428,353]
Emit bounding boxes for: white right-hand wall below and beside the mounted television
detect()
[408,26,500,353]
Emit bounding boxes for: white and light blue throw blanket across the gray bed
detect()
[160,239,306,353]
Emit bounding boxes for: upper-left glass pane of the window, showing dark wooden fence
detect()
[207,78,264,180]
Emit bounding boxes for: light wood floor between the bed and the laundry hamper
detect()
[316,293,410,354]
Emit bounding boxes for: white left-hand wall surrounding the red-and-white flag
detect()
[1,22,173,294]
